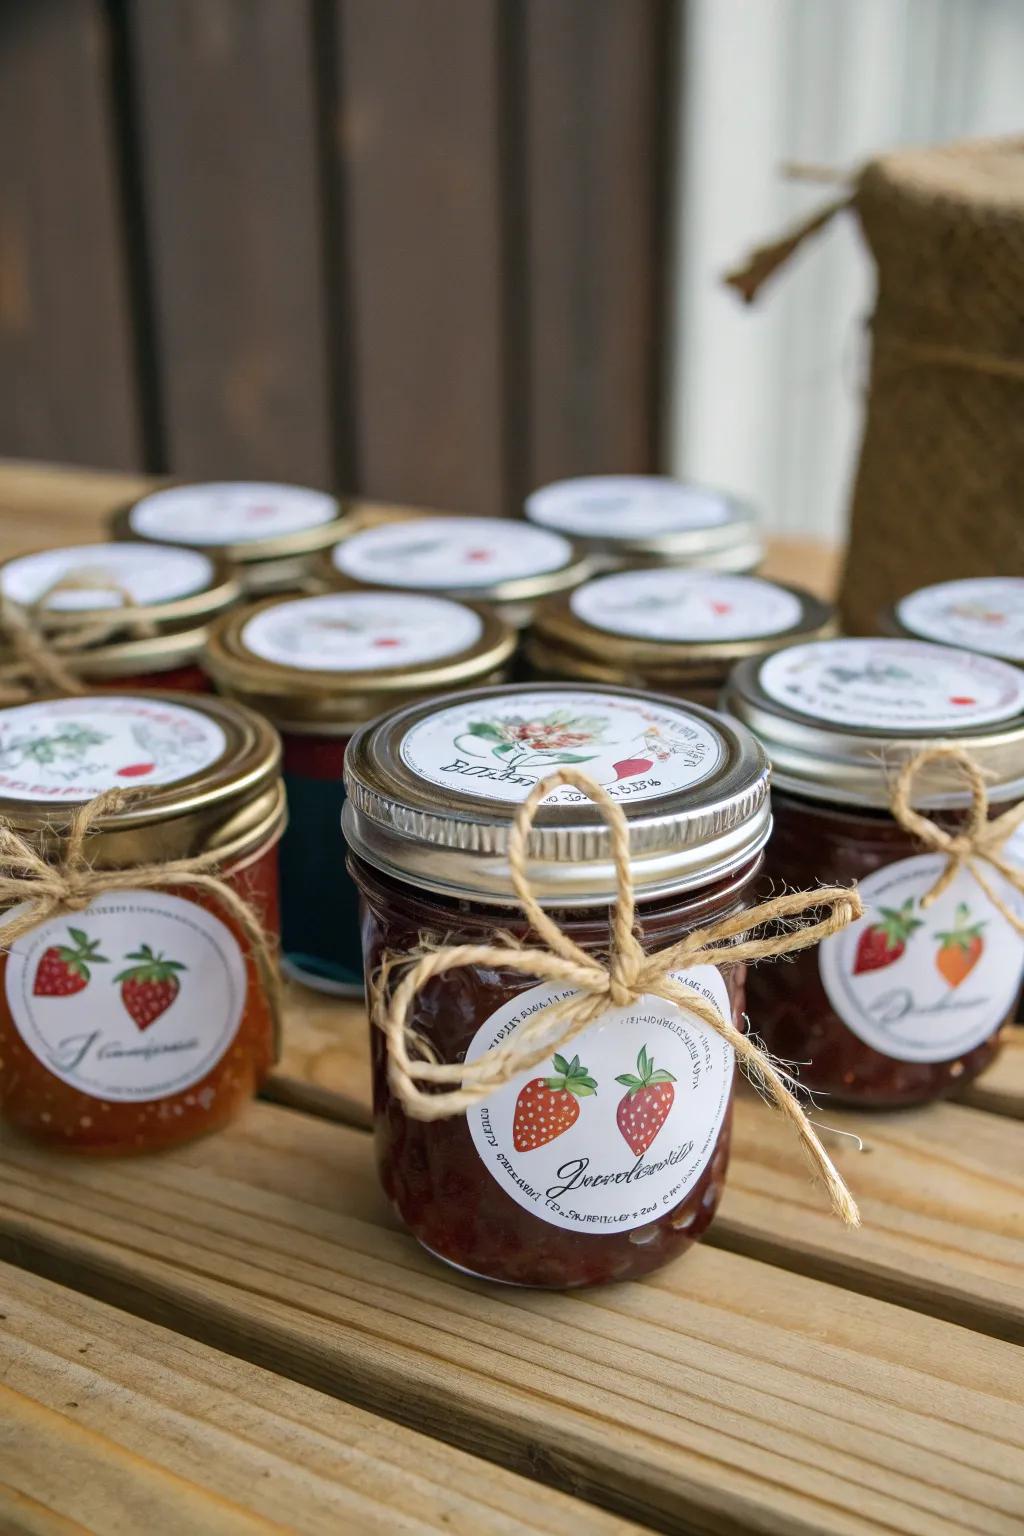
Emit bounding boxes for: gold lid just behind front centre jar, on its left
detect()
[203,591,516,736]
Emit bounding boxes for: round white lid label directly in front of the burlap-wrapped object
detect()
[897,576,1024,662]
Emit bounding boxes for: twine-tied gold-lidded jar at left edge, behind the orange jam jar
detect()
[0,542,238,693]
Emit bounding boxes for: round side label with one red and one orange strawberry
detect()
[818,848,1024,1061]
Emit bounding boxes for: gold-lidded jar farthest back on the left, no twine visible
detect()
[111,481,350,593]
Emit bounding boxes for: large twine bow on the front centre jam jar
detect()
[370,768,863,1226]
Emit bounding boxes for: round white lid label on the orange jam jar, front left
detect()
[0,694,227,800]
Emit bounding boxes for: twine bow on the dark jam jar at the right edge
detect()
[889,746,1024,938]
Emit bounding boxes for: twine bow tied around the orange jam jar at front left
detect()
[0,790,282,1057]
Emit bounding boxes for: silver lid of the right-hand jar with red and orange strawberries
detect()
[723,639,1024,808]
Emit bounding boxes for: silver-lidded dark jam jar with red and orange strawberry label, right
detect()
[726,639,1024,1107]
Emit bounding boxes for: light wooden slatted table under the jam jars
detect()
[0,457,1024,1536]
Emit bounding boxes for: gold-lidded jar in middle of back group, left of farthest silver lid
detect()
[321,507,590,628]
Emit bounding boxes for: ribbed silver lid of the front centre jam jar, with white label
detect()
[342,684,771,906]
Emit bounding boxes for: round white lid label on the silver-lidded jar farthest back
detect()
[527,475,735,539]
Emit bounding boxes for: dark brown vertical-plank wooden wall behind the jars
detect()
[0,0,671,513]
